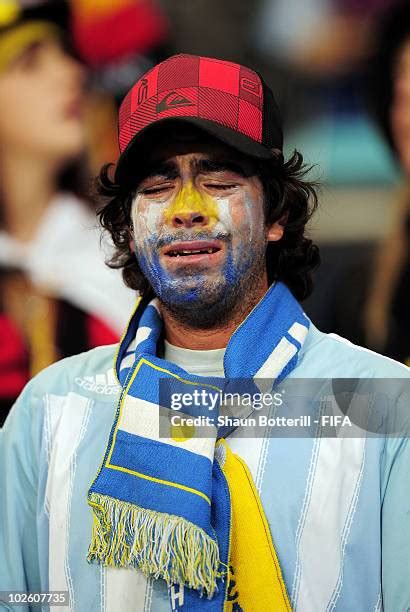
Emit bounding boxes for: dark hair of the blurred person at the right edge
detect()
[368,0,410,154]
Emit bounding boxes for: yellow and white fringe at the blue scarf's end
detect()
[87,493,226,598]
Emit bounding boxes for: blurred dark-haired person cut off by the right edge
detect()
[364,0,410,364]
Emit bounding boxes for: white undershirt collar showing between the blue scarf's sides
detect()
[164,340,226,378]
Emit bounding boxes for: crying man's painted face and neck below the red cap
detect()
[125,125,288,334]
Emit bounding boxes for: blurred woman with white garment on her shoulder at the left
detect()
[0,0,134,423]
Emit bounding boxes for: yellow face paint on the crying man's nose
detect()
[164,181,219,230]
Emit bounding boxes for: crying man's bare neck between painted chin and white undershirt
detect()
[160,281,268,351]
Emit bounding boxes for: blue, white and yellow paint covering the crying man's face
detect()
[132,155,267,326]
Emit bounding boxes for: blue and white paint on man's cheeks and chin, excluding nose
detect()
[134,176,266,308]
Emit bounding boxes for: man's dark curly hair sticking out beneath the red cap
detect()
[96,151,319,301]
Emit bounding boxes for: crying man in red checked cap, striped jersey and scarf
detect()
[0,55,410,612]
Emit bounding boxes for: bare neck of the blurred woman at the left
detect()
[0,152,58,242]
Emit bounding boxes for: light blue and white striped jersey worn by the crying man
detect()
[0,325,410,612]
